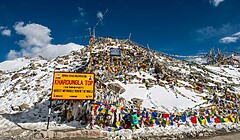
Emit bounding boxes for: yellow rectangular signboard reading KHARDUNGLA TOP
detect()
[51,72,94,100]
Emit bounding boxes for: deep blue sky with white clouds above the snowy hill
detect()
[0,0,240,62]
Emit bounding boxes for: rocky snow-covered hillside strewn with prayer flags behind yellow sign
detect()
[0,38,240,139]
